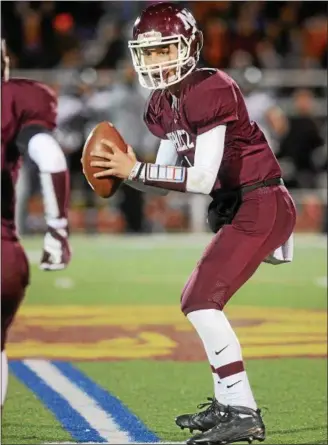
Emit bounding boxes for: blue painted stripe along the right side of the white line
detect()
[52,361,160,443]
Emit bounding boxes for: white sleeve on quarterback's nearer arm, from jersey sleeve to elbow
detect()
[186,125,226,195]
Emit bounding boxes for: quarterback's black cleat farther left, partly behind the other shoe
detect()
[175,397,227,433]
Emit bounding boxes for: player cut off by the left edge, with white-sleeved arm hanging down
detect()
[1,41,71,407]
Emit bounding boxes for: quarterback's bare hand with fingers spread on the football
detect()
[90,139,137,179]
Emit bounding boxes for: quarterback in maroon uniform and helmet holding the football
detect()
[92,3,296,444]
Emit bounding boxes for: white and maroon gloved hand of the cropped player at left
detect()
[40,226,71,270]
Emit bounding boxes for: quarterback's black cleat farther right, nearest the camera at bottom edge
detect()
[187,406,265,445]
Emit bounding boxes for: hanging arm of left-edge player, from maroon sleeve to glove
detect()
[16,82,71,270]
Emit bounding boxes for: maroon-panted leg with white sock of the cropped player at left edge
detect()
[1,240,29,409]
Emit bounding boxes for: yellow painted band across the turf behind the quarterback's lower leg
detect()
[8,306,327,359]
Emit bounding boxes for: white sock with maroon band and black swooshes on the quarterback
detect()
[187,309,257,410]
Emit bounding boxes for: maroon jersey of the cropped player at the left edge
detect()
[1,79,57,239]
